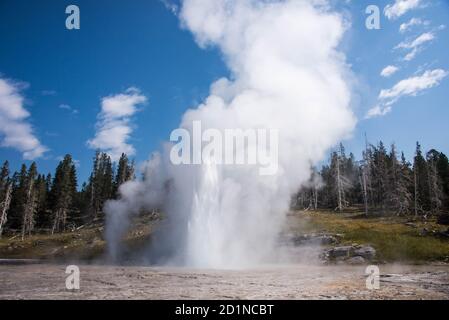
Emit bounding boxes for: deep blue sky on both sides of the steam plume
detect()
[0,0,449,181]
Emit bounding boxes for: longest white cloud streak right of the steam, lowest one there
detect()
[366,69,449,118]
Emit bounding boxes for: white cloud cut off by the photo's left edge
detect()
[0,78,48,160]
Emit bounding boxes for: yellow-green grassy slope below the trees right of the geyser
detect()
[300,212,449,263]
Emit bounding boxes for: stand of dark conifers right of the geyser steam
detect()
[292,142,449,216]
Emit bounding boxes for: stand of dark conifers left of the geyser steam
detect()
[0,151,135,239]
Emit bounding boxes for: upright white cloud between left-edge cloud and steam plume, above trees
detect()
[87,88,147,161]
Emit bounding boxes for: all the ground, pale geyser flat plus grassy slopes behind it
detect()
[0,212,449,299]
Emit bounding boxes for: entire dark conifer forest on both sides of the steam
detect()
[0,142,449,239]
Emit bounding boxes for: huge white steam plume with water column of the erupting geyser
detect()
[106,0,356,268]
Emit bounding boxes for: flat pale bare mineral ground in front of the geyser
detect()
[0,264,449,299]
